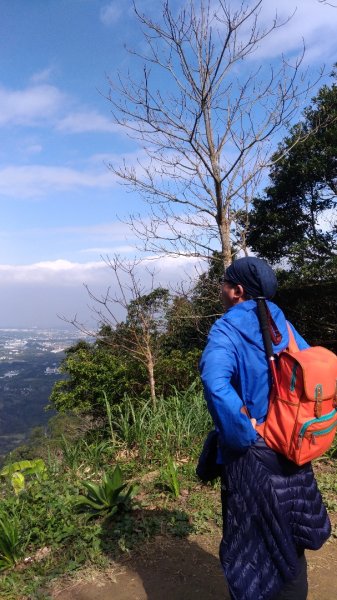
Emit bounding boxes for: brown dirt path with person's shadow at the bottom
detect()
[53,535,337,600]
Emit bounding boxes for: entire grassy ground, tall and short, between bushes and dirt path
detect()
[0,389,337,600]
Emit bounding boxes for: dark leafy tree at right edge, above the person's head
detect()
[248,72,337,281]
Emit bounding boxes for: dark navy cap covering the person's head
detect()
[225,256,277,298]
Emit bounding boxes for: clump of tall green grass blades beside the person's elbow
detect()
[111,386,212,460]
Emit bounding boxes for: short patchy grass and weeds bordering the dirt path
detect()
[0,460,219,600]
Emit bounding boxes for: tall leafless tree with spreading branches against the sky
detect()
[108,0,318,266]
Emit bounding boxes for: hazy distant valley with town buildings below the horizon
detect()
[0,329,83,456]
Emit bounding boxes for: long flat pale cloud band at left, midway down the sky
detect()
[0,165,115,198]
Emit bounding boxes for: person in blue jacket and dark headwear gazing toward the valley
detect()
[200,257,331,600]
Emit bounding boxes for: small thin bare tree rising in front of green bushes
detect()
[65,256,169,406]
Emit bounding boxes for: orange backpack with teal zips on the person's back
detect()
[256,302,337,465]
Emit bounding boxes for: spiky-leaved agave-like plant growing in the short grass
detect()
[75,465,138,517]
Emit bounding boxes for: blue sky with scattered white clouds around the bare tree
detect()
[0,0,337,327]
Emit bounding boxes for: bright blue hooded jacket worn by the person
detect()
[200,300,308,454]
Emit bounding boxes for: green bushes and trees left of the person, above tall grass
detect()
[50,270,223,420]
